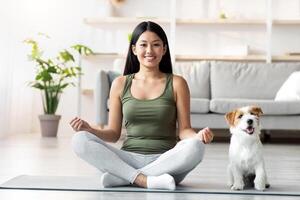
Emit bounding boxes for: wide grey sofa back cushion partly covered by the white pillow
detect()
[211,62,300,99]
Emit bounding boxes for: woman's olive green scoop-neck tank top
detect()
[121,74,177,154]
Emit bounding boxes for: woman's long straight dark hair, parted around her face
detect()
[123,21,172,75]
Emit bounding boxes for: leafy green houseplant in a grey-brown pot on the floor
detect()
[24,34,93,137]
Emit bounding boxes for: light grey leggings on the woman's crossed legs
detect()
[72,131,204,185]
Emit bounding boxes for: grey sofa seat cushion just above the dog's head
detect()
[210,98,300,115]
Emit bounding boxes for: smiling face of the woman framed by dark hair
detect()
[132,31,167,68]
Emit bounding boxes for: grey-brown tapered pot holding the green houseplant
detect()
[39,114,61,137]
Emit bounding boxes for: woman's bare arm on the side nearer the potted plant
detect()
[70,76,126,142]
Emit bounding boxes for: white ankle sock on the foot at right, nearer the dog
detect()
[147,174,176,190]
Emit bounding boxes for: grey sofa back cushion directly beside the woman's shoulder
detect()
[173,61,210,98]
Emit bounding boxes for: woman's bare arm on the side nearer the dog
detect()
[173,75,213,143]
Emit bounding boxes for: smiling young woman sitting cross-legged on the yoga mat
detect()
[70,21,213,190]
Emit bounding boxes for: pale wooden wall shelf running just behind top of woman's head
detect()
[83,17,170,25]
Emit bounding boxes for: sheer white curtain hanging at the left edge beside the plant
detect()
[0,1,35,138]
